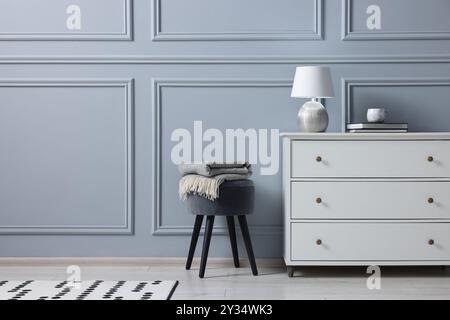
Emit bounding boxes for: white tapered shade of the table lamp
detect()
[291,66,334,98]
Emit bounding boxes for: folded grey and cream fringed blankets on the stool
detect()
[178,162,252,201]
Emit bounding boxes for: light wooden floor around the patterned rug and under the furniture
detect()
[0,259,450,300]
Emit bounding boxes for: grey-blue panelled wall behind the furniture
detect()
[0,0,450,257]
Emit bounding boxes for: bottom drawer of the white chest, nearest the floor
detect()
[291,222,450,261]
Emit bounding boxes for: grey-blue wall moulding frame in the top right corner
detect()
[341,0,450,41]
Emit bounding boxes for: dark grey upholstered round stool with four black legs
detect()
[186,180,258,278]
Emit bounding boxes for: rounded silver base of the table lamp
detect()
[298,101,328,132]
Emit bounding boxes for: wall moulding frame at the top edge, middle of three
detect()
[151,0,323,41]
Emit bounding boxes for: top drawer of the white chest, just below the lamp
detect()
[291,140,450,178]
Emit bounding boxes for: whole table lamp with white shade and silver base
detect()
[291,66,334,132]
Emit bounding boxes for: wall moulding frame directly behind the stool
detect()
[152,78,286,236]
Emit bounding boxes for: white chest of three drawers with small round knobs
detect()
[282,133,450,276]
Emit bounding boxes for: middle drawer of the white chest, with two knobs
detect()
[291,180,450,219]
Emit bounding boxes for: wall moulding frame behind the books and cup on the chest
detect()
[341,77,450,132]
